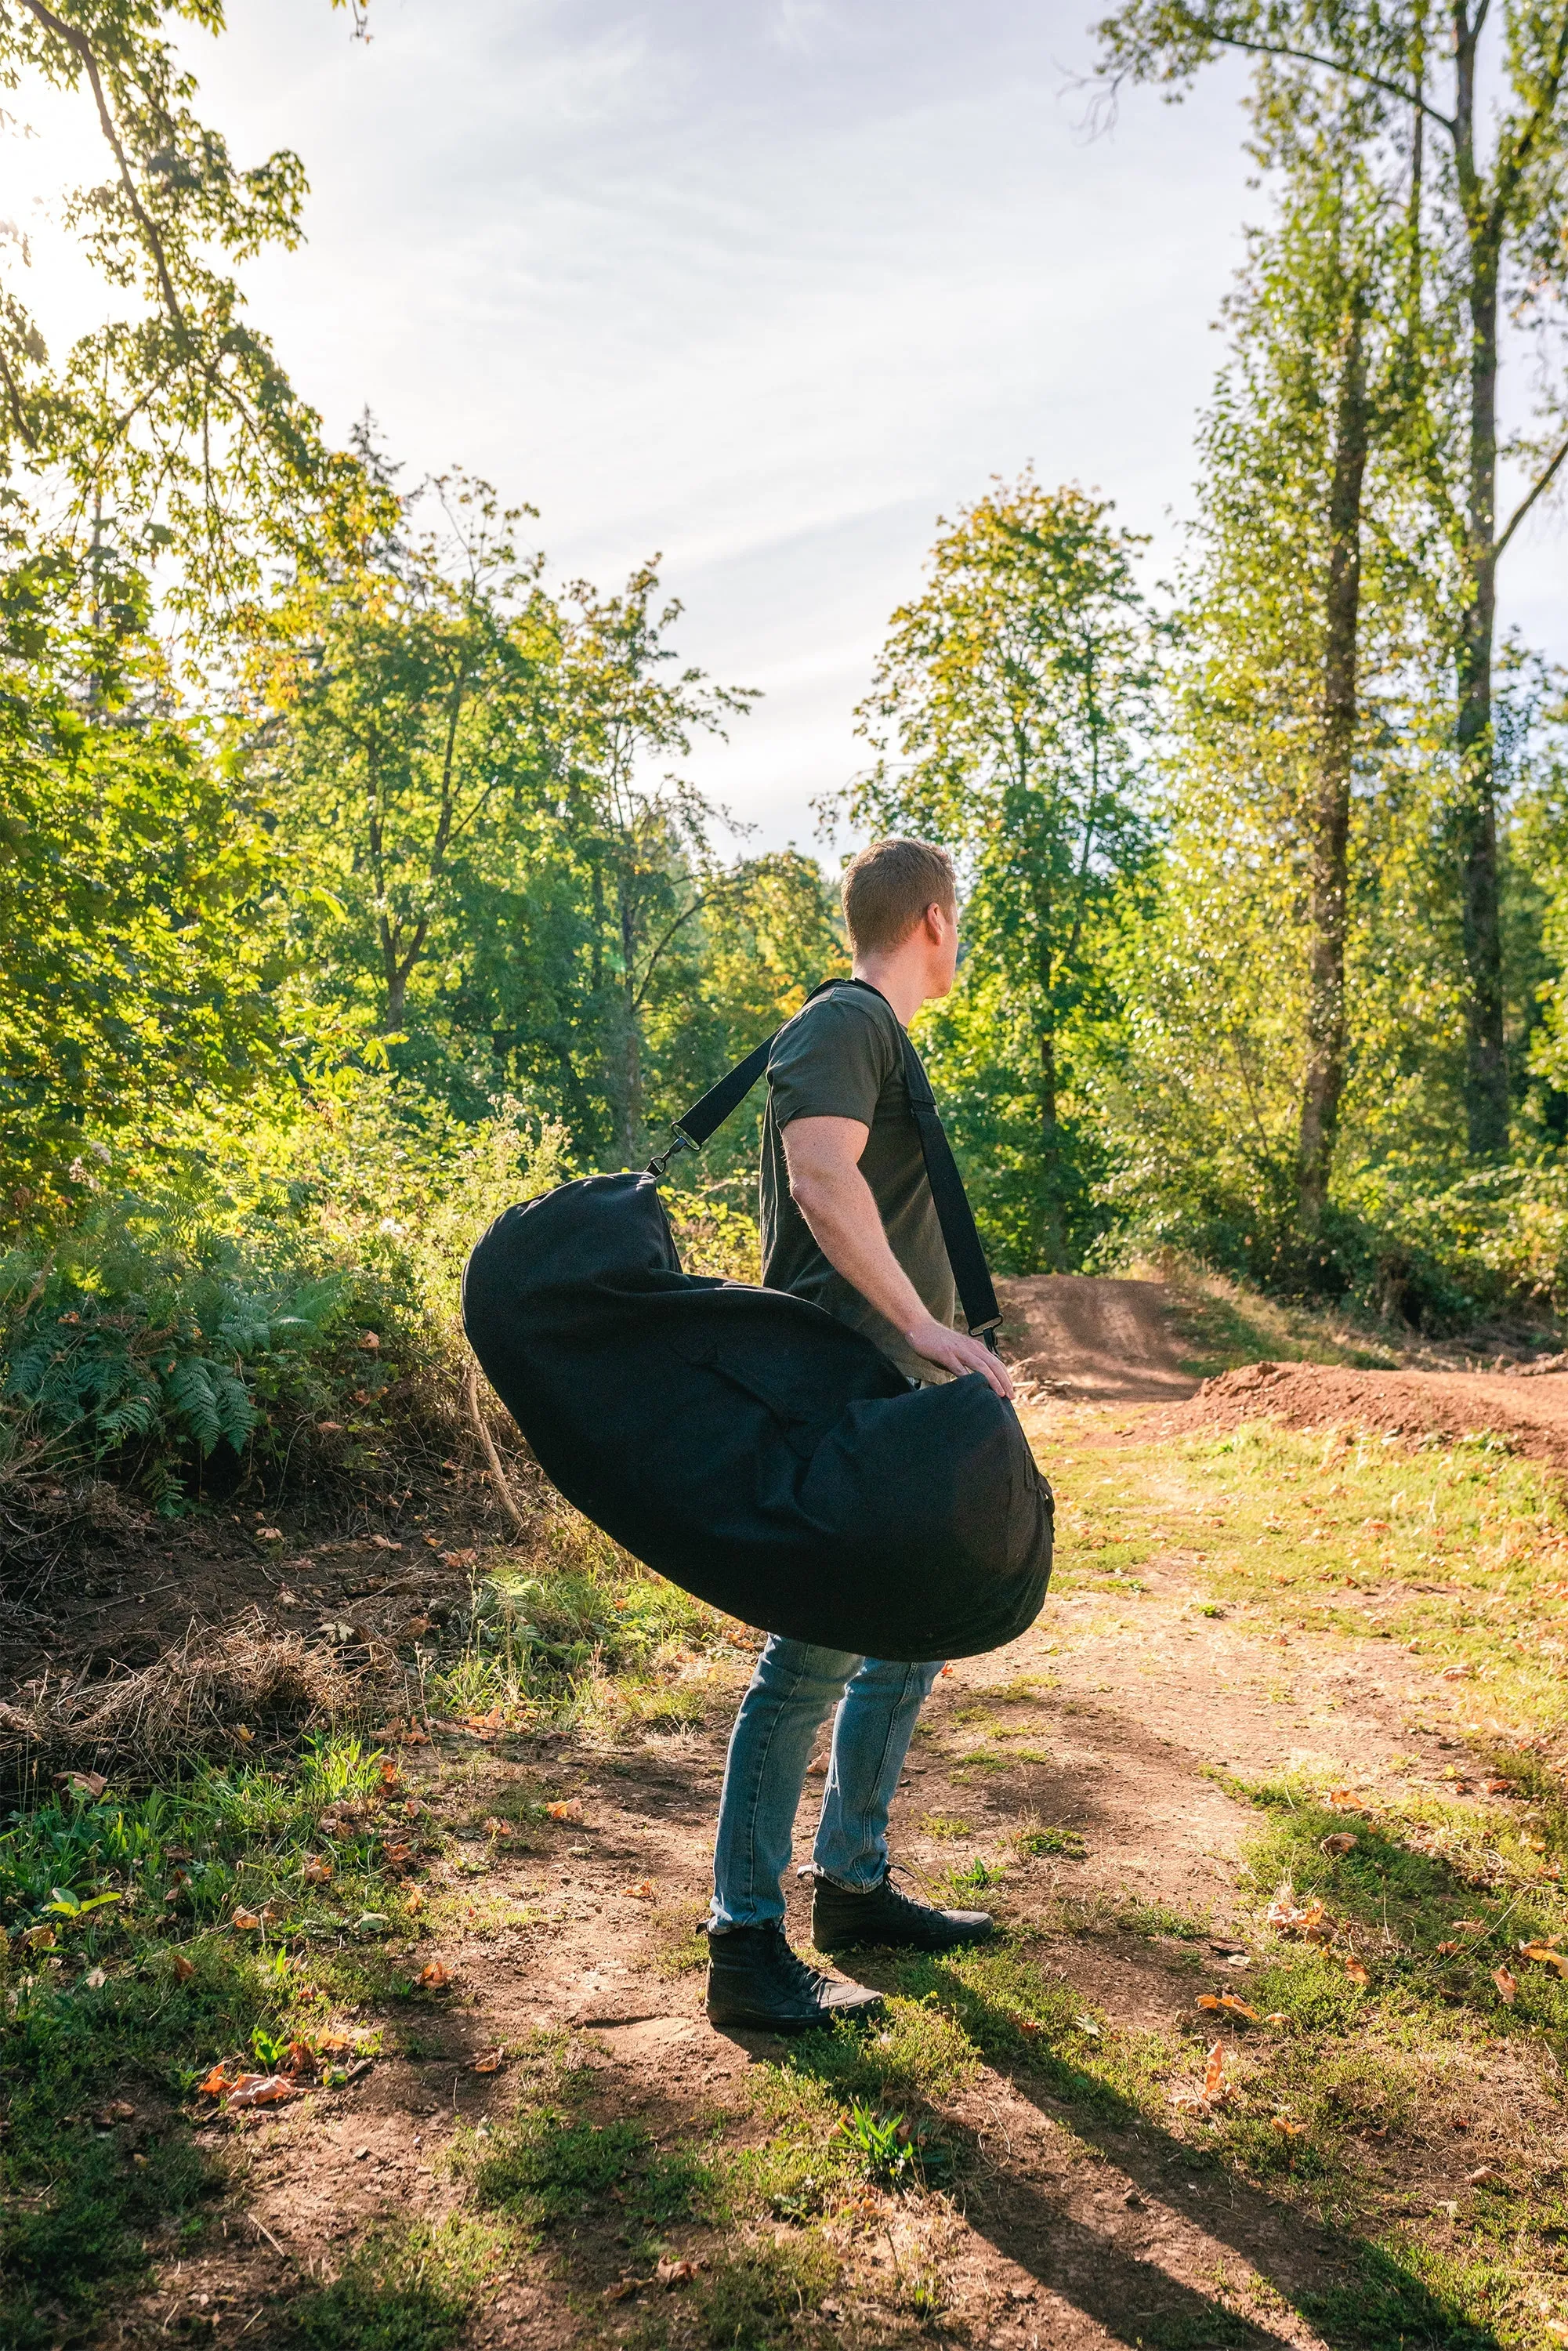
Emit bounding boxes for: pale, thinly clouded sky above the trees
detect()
[0,0,1568,849]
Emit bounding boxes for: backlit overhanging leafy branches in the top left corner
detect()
[0,0,350,632]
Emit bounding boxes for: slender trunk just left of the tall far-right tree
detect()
[1295,296,1368,1234]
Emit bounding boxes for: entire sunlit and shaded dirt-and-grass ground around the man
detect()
[0,1298,1568,2351]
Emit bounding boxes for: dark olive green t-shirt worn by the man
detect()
[762,987,959,1385]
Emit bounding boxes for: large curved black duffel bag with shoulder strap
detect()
[463,983,1051,1662]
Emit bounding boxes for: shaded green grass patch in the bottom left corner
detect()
[0,1737,442,2351]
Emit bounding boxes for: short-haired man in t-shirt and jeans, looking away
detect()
[708,839,1013,2031]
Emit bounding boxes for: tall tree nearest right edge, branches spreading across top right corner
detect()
[1100,0,1568,1154]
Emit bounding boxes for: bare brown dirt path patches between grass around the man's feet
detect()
[122,1406,1523,2351]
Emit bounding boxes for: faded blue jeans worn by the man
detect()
[710,1634,940,1935]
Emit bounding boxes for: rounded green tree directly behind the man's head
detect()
[842,473,1154,1267]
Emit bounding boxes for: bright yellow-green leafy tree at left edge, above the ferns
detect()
[0,552,282,1225]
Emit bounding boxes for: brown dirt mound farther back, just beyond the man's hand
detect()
[997,1274,1197,1404]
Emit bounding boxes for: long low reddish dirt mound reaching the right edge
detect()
[1138,1364,1568,1472]
